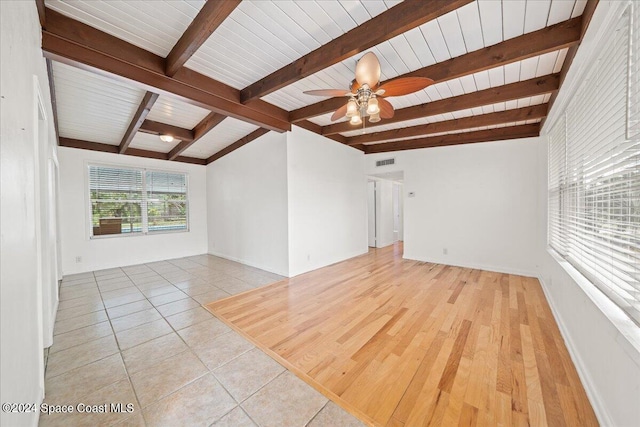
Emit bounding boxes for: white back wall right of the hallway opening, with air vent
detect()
[366,138,541,276]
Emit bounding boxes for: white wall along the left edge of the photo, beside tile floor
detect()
[0,1,57,426]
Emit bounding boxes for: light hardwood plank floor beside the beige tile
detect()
[207,244,598,427]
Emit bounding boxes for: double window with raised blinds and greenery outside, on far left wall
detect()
[89,165,189,236]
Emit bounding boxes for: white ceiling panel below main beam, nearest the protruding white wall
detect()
[182,117,258,159]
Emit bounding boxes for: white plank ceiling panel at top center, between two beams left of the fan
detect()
[185,0,392,89]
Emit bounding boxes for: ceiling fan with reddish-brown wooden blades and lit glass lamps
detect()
[304,52,434,128]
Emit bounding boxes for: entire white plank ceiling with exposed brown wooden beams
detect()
[36,0,597,164]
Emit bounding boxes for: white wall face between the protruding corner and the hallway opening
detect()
[287,126,368,276]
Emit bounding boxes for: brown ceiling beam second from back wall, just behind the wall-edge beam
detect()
[347,104,548,145]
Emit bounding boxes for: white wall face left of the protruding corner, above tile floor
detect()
[207,132,289,276]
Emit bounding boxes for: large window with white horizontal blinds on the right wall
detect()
[548,6,640,324]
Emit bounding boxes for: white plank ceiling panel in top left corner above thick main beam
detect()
[45,0,205,57]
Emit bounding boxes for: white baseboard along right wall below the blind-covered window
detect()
[538,276,614,426]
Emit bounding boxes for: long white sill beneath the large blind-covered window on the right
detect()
[547,247,640,367]
